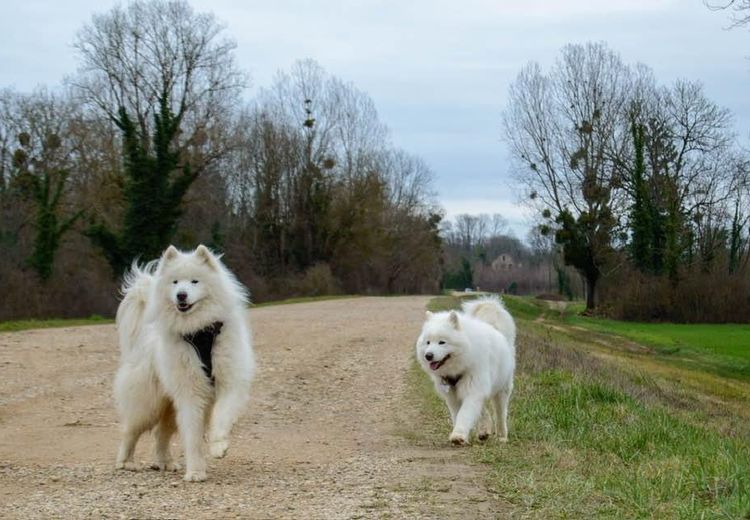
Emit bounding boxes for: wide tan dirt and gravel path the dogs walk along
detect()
[0,297,501,519]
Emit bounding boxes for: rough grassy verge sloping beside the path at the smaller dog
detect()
[411,297,750,519]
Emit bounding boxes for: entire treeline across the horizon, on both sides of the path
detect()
[0,0,750,322]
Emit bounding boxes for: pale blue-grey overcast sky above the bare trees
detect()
[0,0,750,236]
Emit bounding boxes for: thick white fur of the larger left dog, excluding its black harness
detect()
[114,245,255,481]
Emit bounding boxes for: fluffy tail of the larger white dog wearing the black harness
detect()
[115,261,157,354]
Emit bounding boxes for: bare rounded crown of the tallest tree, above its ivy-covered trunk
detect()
[70,0,247,146]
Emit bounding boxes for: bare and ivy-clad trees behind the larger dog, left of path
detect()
[0,0,452,319]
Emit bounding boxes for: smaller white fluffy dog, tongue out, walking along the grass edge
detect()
[416,297,516,444]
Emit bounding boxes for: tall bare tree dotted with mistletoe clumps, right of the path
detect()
[503,43,632,310]
